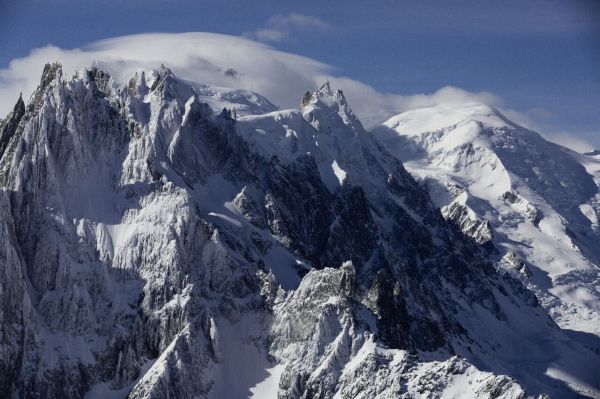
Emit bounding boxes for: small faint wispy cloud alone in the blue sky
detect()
[244,13,331,43]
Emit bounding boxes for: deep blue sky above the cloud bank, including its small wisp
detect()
[0,0,600,146]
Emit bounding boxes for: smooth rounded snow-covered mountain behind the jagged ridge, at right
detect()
[375,104,600,335]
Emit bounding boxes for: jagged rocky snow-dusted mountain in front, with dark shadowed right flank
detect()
[0,64,600,398]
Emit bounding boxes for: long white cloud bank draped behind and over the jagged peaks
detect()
[0,33,516,127]
